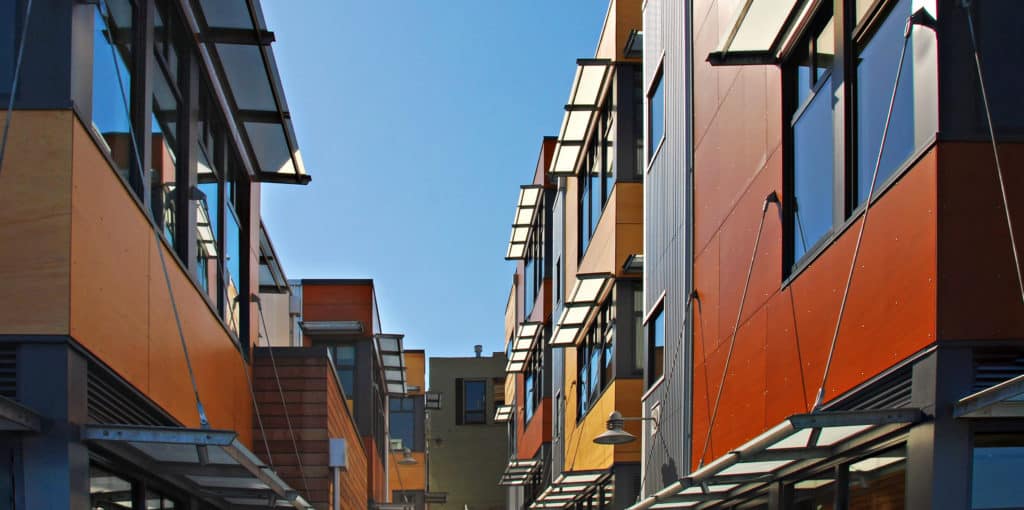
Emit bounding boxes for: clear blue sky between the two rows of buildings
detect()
[262,0,607,355]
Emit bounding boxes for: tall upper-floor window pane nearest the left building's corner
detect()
[91,0,140,193]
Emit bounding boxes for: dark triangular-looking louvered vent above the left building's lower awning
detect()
[88,364,176,426]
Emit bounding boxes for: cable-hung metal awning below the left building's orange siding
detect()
[82,425,312,510]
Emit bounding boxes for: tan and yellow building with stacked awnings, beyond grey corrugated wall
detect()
[502,0,645,509]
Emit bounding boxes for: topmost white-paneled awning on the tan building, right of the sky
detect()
[548,58,613,175]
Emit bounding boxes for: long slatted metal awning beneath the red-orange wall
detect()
[630,409,925,510]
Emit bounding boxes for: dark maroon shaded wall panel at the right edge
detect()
[938,142,1024,340]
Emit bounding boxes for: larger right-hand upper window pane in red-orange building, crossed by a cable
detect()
[855,0,914,205]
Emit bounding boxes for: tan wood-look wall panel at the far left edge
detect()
[0,111,75,335]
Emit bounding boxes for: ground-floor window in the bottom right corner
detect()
[971,433,1024,510]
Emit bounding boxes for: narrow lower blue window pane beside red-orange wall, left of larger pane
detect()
[792,78,835,261]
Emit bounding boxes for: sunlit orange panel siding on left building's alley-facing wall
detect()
[70,113,252,443]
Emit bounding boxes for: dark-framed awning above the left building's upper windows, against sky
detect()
[186,0,310,184]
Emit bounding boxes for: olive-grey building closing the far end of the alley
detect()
[427,346,507,510]
